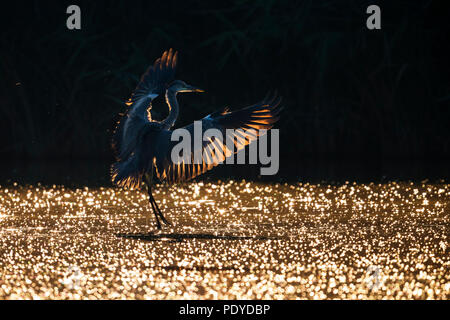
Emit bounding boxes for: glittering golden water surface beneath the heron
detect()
[0,181,450,299]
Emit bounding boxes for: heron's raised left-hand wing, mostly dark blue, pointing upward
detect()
[112,49,178,161]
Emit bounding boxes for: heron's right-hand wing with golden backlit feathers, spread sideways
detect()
[155,92,282,183]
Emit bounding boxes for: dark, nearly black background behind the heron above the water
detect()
[0,0,450,183]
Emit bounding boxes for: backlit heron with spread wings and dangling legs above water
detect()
[111,49,282,229]
